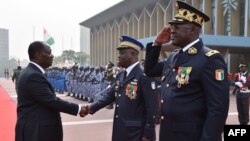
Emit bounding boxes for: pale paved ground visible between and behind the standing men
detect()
[0,78,242,141]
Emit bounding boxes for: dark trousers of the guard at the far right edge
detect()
[236,92,249,125]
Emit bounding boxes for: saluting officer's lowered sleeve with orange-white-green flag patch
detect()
[201,54,229,141]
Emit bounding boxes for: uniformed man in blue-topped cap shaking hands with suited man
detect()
[84,36,157,141]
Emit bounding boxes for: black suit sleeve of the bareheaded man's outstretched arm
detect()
[27,73,79,115]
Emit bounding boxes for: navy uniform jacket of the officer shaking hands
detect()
[91,64,156,141]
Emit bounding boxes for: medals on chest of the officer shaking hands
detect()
[126,80,138,100]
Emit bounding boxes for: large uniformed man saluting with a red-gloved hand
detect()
[145,1,229,141]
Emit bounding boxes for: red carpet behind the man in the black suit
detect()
[0,86,16,141]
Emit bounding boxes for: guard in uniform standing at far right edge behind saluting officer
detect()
[234,63,250,125]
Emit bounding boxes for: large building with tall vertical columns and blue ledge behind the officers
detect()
[80,0,250,72]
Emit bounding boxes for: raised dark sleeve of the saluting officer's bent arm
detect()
[144,43,164,77]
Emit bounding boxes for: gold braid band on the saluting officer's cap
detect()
[175,9,204,25]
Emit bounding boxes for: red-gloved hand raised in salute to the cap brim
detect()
[154,24,171,45]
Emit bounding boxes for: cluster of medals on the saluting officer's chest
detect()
[176,67,192,88]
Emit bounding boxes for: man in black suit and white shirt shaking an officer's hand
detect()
[15,41,84,141]
